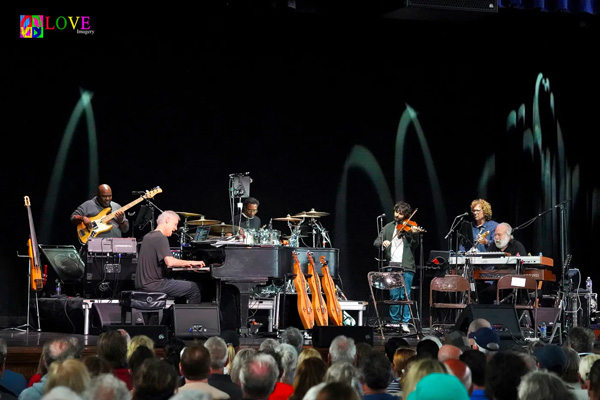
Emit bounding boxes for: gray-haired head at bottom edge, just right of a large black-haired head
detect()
[519,370,575,400]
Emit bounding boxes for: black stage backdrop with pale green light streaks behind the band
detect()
[0,4,599,324]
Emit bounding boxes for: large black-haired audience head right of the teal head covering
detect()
[485,351,529,400]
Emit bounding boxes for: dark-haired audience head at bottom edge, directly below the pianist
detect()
[132,357,179,400]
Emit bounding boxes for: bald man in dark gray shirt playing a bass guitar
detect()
[71,184,129,245]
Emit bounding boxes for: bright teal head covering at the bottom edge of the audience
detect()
[406,374,469,400]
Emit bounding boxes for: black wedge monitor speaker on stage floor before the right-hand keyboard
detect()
[455,304,523,340]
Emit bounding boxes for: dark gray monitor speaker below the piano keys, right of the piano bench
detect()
[162,303,221,339]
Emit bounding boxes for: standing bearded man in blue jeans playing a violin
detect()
[373,201,422,333]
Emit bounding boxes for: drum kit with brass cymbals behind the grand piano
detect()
[176,208,331,247]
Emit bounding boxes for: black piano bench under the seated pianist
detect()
[119,290,167,325]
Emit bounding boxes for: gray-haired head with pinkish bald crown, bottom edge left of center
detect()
[240,353,279,400]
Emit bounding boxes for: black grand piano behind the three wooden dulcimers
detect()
[182,243,339,332]
